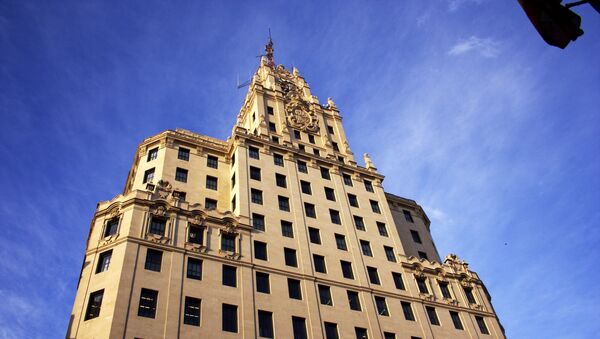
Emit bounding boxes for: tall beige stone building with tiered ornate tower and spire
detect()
[67,42,504,339]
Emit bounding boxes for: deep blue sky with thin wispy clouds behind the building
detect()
[0,0,600,338]
